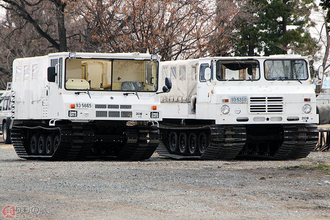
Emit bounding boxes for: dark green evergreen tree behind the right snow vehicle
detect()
[236,0,318,55]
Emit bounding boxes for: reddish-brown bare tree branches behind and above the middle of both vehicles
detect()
[75,0,240,60]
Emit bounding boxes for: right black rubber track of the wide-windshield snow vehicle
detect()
[118,127,160,161]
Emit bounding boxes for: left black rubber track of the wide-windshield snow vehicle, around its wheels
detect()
[12,125,94,160]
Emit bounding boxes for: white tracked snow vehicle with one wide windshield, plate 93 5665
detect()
[11,52,167,160]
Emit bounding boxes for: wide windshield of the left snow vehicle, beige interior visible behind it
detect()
[65,59,158,91]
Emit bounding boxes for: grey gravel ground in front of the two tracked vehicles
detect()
[0,140,330,220]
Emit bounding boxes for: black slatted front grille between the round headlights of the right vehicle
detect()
[250,97,283,113]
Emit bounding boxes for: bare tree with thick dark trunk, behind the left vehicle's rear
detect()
[0,0,77,87]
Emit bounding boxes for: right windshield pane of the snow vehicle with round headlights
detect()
[265,60,308,80]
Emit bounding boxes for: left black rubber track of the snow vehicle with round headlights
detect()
[156,125,246,160]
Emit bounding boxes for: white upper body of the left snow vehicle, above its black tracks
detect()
[13,53,161,123]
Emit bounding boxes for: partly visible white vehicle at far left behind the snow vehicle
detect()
[0,83,12,144]
